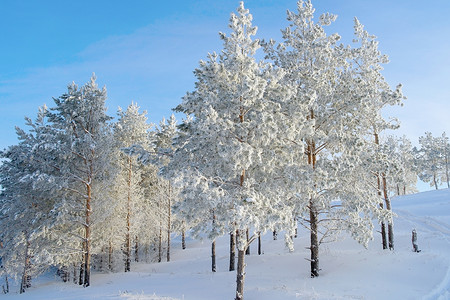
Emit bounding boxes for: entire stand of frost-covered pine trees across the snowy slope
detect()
[0,0,450,299]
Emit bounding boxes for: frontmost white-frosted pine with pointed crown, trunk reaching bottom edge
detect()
[171,2,293,299]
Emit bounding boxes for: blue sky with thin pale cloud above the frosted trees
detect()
[0,0,450,190]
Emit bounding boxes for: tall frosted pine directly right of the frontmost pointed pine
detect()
[265,1,404,277]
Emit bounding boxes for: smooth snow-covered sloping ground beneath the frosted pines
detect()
[0,189,450,300]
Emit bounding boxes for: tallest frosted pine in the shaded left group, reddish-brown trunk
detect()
[41,75,115,287]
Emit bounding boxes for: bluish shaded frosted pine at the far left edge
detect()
[0,106,57,293]
